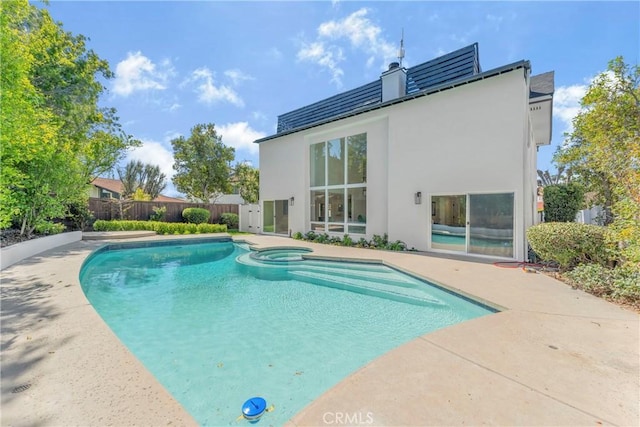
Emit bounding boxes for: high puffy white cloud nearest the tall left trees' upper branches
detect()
[113,51,175,96]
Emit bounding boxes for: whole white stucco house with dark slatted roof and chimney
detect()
[256,44,554,260]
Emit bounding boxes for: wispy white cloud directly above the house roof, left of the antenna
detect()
[297,8,397,88]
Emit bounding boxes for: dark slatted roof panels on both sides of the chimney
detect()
[277,43,480,133]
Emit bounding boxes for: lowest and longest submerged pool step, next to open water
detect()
[289,271,446,307]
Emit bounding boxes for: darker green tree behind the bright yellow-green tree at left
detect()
[25,8,140,184]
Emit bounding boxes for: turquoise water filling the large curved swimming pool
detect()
[80,240,492,425]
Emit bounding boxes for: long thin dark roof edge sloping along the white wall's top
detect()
[254,60,531,144]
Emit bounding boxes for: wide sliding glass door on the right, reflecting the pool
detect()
[431,193,514,258]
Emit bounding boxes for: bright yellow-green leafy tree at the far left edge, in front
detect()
[0,1,77,235]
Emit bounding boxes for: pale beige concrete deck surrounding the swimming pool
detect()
[0,236,640,426]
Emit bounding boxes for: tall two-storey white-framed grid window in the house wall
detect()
[309,133,367,234]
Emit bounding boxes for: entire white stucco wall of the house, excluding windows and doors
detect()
[260,69,536,260]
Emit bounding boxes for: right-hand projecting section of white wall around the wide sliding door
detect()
[388,69,535,259]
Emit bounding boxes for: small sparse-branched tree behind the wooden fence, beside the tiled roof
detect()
[117,160,167,200]
